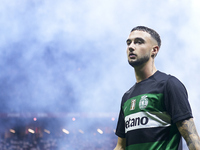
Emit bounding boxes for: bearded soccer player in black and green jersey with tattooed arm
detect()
[115,26,200,150]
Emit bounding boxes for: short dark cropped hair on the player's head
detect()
[131,26,161,47]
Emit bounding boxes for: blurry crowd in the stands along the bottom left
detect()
[0,135,116,150]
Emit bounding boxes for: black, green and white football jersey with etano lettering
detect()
[116,71,192,150]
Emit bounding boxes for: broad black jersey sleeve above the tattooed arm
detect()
[165,76,193,123]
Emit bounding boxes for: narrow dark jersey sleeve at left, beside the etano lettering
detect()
[115,98,126,138]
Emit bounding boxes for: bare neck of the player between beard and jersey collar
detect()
[134,64,157,83]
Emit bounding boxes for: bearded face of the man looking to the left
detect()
[126,30,155,67]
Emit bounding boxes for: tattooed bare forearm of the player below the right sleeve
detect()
[176,118,200,150]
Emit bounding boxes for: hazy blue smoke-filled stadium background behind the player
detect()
[0,0,200,150]
